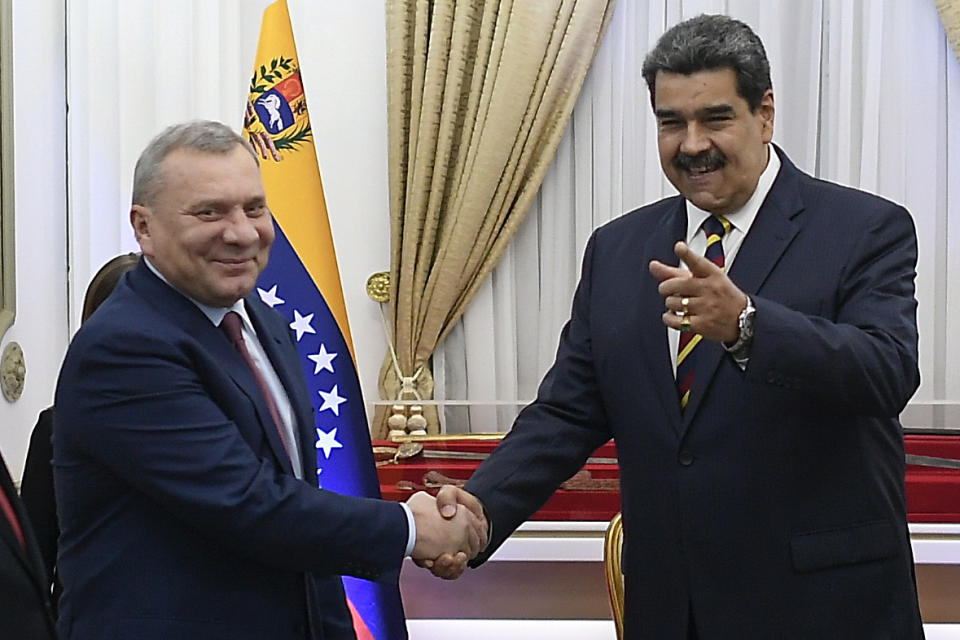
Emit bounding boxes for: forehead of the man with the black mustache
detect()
[654,67,746,111]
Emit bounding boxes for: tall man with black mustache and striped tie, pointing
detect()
[433,15,923,640]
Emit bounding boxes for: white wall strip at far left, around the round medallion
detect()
[0,0,67,479]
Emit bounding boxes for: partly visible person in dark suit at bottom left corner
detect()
[0,444,57,640]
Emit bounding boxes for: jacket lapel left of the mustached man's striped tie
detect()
[637,197,687,432]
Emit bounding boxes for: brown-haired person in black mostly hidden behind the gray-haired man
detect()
[20,253,139,618]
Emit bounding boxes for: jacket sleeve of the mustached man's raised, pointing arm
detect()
[746,203,920,416]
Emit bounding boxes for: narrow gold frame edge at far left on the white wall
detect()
[0,0,17,338]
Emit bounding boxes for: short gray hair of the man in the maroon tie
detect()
[133,120,260,205]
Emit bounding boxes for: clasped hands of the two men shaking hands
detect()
[407,485,488,580]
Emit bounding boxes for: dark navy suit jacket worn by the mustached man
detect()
[467,151,923,640]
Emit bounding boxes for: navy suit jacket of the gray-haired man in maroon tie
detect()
[53,261,407,640]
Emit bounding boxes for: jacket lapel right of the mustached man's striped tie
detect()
[683,148,803,429]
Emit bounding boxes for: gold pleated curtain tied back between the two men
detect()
[374,0,616,436]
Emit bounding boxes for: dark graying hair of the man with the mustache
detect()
[642,14,773,111]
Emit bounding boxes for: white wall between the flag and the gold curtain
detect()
[289,0,390,419]
